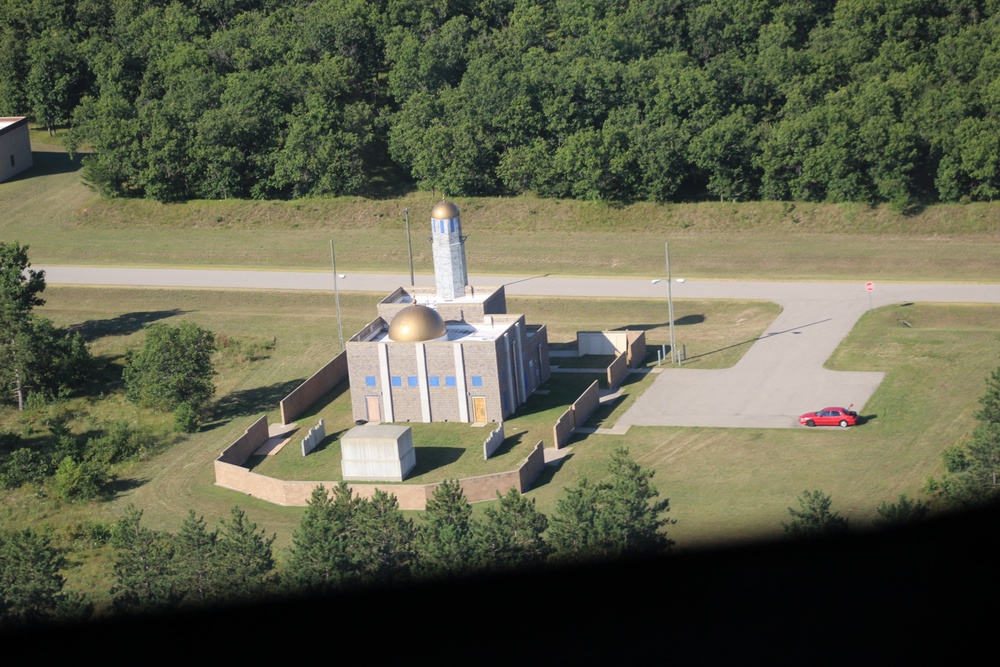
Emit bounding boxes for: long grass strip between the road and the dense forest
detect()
[0,136,1000,282]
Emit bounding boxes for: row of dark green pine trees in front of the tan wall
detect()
[0,449,673,628]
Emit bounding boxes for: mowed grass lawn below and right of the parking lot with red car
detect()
[516,304,1000,548]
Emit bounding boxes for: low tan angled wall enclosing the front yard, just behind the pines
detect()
[215,436,545,510]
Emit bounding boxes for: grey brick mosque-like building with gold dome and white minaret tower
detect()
[347,201,550,422]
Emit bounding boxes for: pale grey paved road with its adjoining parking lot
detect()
[35,266,1000,428]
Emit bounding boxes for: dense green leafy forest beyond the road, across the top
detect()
[0,0,1000,207]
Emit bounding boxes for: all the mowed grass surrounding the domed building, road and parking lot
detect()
[0,133,1000,595]
